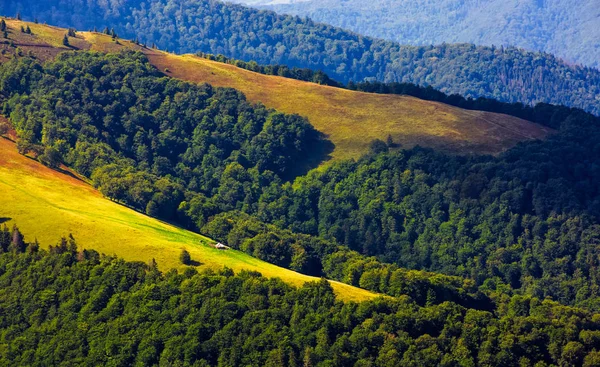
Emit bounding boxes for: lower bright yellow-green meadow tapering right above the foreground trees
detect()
[0,138,376,301]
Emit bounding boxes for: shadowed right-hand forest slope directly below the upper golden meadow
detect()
[243,111,600,309]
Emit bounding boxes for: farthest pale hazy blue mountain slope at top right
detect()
[235,0,600,68]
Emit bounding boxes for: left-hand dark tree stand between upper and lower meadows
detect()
[0,51,326,224]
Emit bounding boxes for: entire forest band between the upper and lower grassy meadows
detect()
[0,52,600,316]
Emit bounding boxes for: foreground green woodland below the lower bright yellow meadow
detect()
[0,226,600,367]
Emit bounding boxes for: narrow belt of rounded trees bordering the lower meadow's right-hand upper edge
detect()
[202,212,492,309]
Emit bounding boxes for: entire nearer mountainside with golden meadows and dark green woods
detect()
[0,14,600,367]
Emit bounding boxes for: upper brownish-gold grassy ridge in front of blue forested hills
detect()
[1,20,552,163]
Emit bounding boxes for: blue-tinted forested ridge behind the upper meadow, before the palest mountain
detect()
[0,0,600,113]
